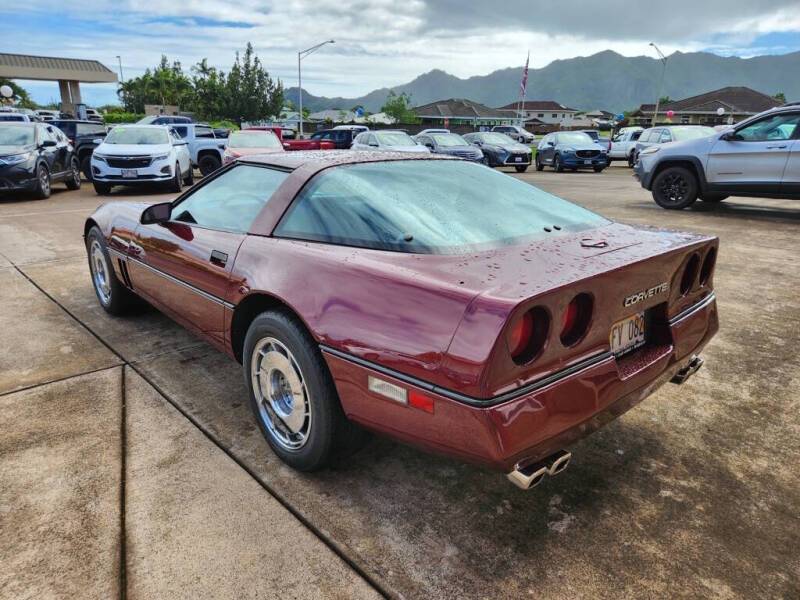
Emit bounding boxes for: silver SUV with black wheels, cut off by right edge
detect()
[634,104,800,209]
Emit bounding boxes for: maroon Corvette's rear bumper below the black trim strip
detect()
[323,296,718,472]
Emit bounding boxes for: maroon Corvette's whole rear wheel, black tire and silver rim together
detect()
[243,311,364,471]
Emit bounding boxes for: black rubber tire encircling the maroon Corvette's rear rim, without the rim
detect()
[242,311,344,471]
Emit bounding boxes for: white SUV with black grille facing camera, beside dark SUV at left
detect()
[91,125,194,194]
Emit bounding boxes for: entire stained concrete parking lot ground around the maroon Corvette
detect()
[0,166,800,599]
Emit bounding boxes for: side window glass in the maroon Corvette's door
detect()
[172,165,287,233]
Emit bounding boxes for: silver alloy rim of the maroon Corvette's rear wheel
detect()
[250,337,312,451]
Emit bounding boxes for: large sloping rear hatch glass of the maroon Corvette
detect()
[275,160,609,254]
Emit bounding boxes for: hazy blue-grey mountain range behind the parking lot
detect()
[285,50,800,112]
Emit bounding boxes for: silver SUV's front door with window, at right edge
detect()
[706,111,800,193]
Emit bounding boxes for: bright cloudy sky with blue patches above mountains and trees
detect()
[0,0,800,105]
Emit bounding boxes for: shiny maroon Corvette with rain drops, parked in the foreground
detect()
[85,151,718,488]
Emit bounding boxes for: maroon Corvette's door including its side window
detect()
[128,164,287,344]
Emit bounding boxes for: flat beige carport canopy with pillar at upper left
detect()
[0,52,117,113]
